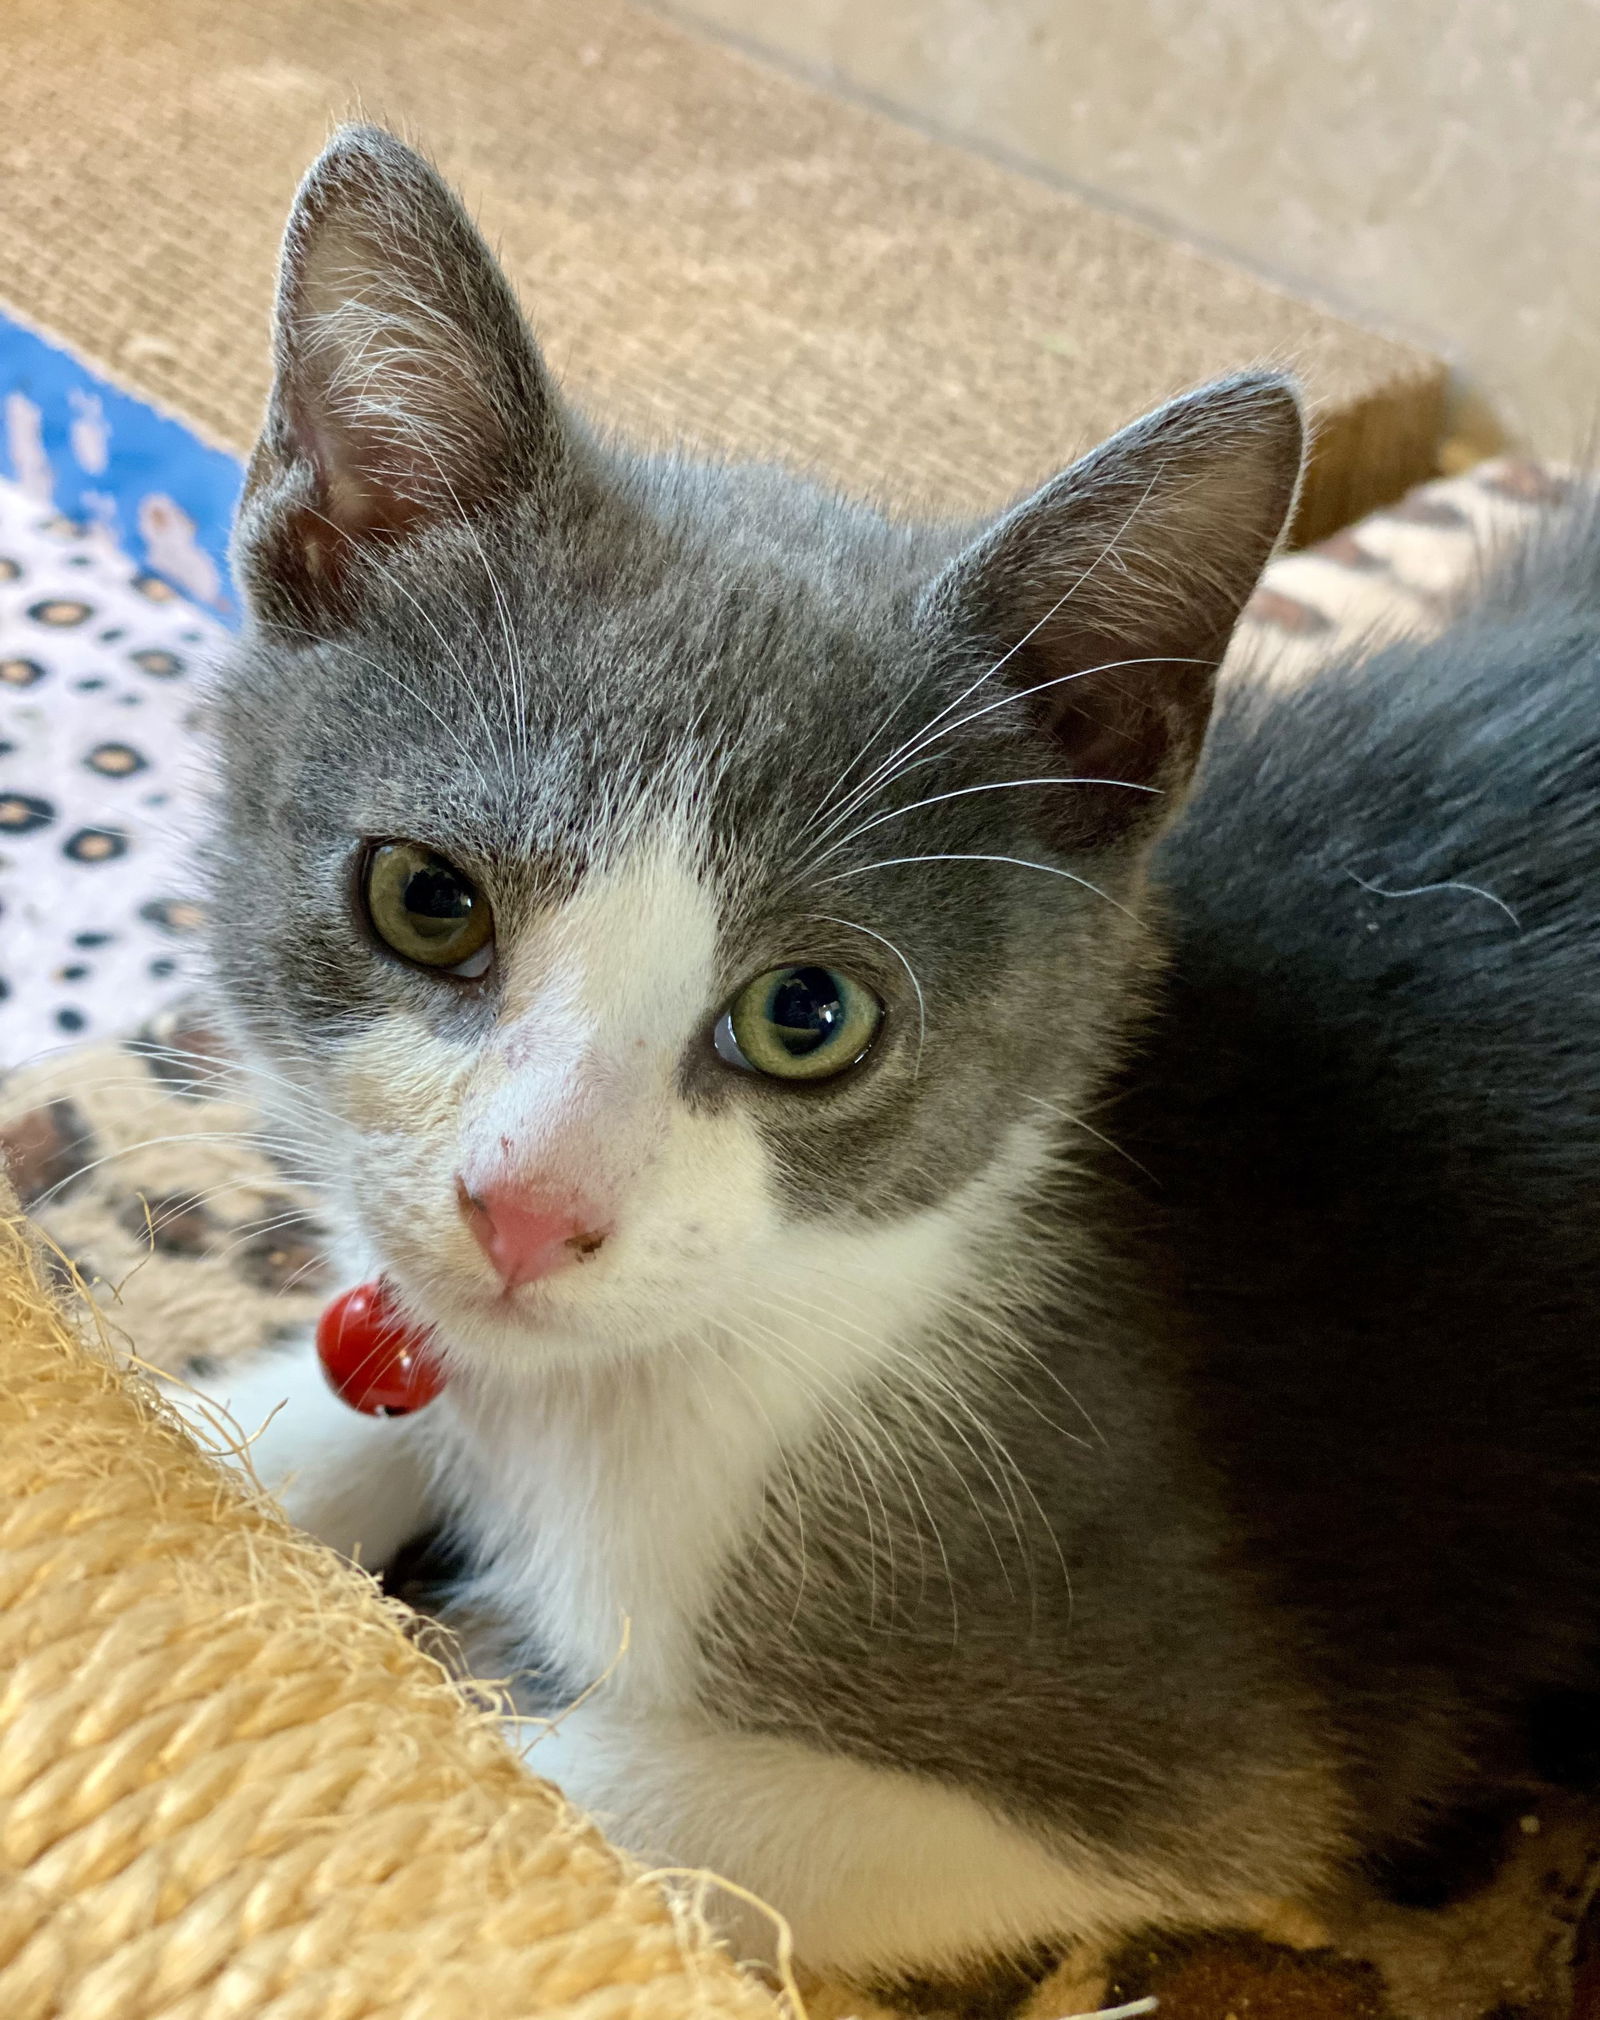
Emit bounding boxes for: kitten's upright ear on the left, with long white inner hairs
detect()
[234,127,564,624]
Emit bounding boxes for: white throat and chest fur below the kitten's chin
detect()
[426,1106,1034,1707]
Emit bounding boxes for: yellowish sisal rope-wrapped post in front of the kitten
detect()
[0,1200,778,2020]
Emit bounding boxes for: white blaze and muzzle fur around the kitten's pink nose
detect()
[341,836,780,1378]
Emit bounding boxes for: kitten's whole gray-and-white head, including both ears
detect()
[216,129,1301,1370]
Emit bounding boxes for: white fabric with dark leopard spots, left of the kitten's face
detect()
[0,481,226,1065]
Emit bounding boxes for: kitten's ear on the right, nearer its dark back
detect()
[923,372,1305,846]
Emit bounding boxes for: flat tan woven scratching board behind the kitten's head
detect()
[0,0,1444,539]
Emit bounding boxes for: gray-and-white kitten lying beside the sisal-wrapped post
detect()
[184,129,1600,1978]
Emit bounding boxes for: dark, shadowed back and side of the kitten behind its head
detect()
[1131,545,1600,1836]
